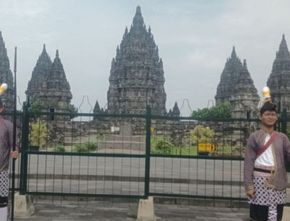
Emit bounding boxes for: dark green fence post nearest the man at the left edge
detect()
[19,102,29,194]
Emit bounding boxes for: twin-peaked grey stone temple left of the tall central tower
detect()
[26,45,72,112]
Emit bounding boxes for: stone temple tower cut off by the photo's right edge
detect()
[267,35,290,114]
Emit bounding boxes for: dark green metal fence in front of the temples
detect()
[9,104,287,206]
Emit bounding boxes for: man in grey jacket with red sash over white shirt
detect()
[244,100,290,221]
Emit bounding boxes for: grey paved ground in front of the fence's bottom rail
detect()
[14,200,290,221]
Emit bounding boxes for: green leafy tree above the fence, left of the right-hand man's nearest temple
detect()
[191,102,232,120]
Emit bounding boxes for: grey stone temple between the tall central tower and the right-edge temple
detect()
[215,47,259,118]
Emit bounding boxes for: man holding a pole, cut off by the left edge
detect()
[0,99,18,221]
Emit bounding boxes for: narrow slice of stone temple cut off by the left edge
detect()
[0,31,14,112]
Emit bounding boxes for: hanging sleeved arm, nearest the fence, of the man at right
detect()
[244,134,256,198]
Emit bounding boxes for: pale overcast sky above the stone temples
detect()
[0,0,290,114]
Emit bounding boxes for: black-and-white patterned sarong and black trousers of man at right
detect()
[249,172,286,221]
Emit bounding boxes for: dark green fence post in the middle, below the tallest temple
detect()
[144,106,151,198]
